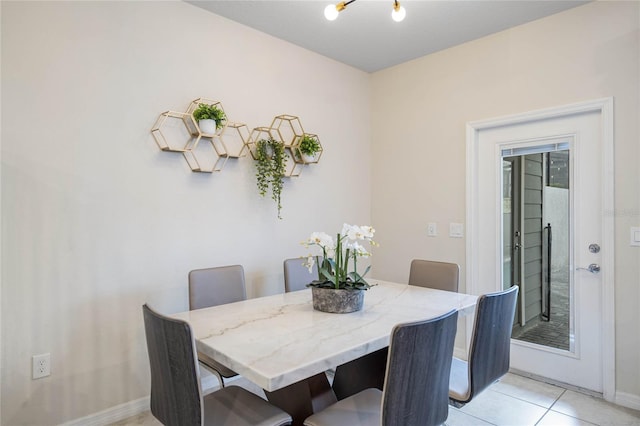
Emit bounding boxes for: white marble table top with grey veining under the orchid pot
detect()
[172,279,477,391]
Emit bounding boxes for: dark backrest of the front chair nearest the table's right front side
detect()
[382,310,458,426]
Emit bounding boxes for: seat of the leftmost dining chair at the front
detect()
[204,386,291,426]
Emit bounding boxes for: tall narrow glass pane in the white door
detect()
[502,144,573,351]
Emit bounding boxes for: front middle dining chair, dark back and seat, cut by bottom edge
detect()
[304,310,458,426]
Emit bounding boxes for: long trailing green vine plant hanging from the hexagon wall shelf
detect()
[256,138,287,219]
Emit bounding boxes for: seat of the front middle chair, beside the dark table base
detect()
[304,388,382,426]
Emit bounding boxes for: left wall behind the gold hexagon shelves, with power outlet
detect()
[0,1,371,425]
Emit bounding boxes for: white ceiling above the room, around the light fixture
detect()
[186,0,587,72]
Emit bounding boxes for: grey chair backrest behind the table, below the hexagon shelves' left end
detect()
[189,265,247,309]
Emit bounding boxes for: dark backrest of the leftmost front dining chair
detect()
[142,304,203,425]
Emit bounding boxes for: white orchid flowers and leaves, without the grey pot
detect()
[302,223,377,290]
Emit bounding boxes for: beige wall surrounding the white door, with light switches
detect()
[372,2,640,407]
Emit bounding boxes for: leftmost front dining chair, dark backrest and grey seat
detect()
[142,304,291,426]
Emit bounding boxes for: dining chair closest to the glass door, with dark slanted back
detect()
[449,286,518,407]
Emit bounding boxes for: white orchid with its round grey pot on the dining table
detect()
[302,223,377,313]
